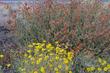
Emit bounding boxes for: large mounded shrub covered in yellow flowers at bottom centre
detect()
[19,41,73,73]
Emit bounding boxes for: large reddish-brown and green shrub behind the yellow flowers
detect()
[17,0,109,54]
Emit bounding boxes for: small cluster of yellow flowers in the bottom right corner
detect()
[86,58,110,72]
